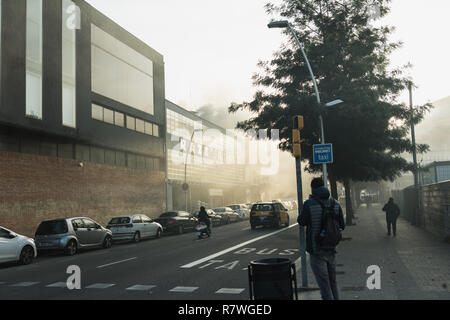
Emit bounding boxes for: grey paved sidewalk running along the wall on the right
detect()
[297,206,450,300]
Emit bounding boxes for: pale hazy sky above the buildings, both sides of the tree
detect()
[88,0,450,109]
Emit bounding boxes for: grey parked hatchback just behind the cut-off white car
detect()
[35,217,112,255]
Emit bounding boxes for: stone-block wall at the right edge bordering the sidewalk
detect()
[422,181,450,240]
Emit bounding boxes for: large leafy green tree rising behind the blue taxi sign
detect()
[229,0,431,224]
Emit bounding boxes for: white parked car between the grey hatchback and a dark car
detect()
[106,214,163,242]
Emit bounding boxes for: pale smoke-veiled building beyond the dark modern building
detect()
[166,101,262,211]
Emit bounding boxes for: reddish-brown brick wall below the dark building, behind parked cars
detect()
[0,151,166,237]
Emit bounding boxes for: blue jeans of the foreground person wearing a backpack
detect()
[309,253,339,300]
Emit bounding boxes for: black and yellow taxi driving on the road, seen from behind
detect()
[250,202,289,229]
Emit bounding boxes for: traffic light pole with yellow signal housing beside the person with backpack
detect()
[292,116,308,288]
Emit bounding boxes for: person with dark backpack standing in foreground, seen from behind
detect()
[297,178,345,300]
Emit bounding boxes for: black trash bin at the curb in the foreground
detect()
[248,258,298,300]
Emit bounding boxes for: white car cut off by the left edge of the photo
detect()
[0,227,37,264]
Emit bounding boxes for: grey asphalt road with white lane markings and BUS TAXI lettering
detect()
[0,213,299,300]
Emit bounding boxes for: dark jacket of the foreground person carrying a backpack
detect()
[297,187,345,254]
